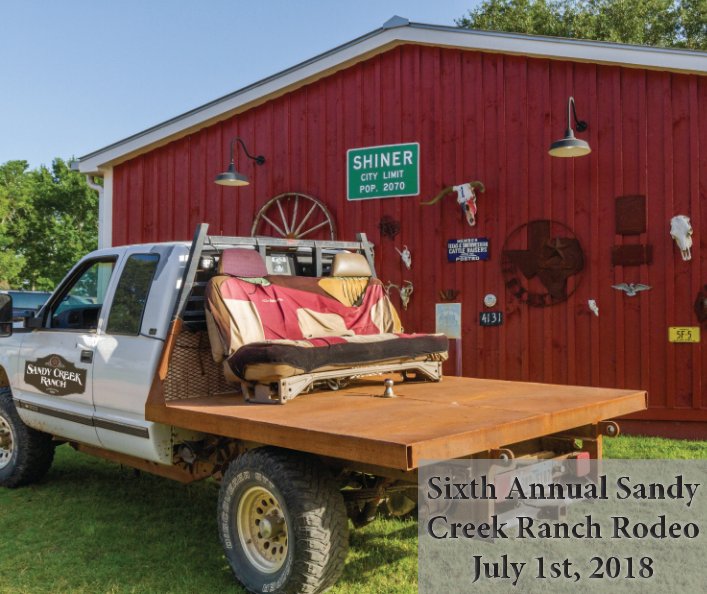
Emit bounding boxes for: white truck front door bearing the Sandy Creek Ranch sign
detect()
[14,256,117,445]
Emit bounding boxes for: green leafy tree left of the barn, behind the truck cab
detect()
[0,159,98,290]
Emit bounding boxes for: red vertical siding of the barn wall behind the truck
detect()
[113,45,707,421]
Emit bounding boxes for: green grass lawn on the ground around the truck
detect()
[0,437,707,594]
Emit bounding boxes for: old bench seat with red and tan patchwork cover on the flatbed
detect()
[205,248,448,402]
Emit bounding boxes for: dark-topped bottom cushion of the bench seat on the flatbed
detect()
[227,333,448,383]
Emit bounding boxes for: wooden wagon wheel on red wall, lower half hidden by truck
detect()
[250,192,336,240]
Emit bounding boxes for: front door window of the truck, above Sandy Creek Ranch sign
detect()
[50,260,115,330]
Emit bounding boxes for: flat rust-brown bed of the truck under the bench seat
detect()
[147,377,646,471]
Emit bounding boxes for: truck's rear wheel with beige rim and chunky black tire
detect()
[218,447,349,594]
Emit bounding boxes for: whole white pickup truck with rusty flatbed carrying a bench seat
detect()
[0,225,646,592]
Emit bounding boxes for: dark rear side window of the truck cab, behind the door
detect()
[106,254,160,335]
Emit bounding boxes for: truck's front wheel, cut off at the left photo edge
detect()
[0,388,54,488]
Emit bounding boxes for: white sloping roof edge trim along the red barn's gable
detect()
[79,19,707,173]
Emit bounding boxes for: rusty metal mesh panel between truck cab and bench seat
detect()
[164,331,239,402]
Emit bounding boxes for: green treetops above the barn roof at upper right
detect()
[456,0,707,50]
